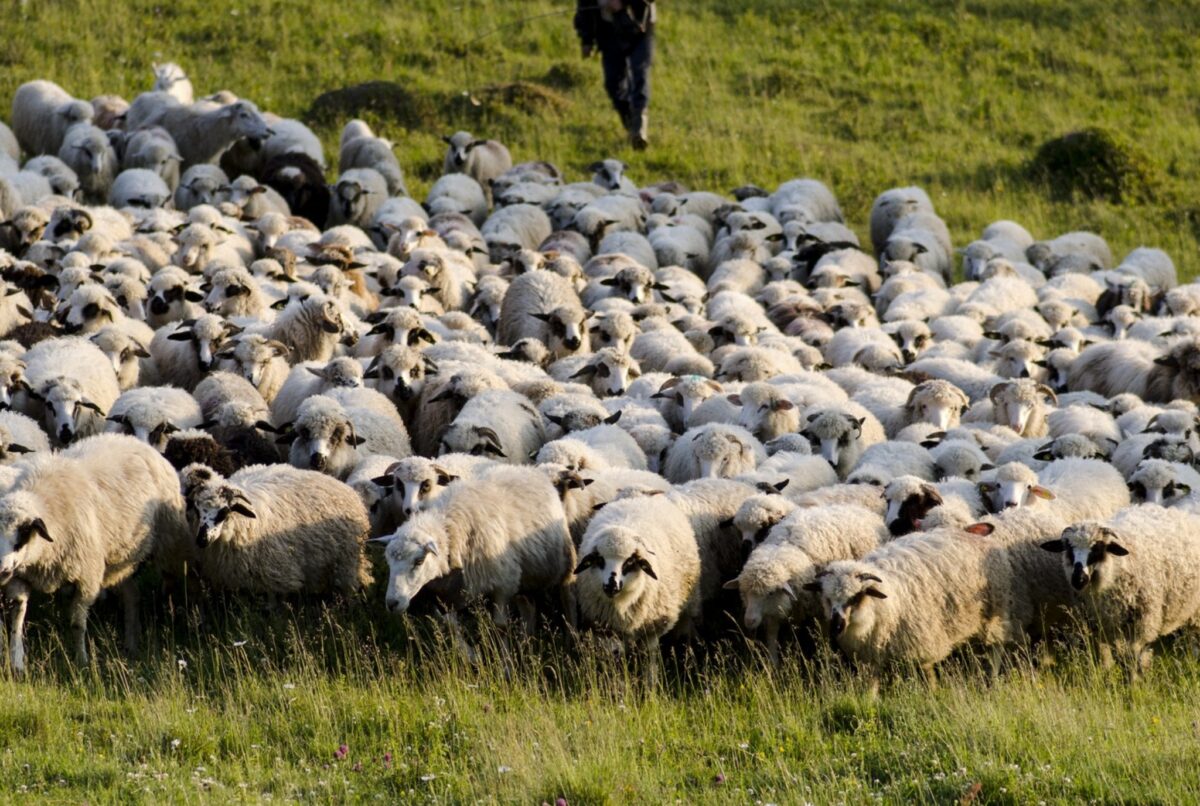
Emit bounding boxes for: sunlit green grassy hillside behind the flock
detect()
[0,0,1200,276]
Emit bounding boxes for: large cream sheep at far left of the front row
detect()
[0,435,187,673]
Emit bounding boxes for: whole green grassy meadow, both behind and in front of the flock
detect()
[0,0,1200,805]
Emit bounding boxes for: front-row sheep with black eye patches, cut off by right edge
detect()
[1042,505,1200,680]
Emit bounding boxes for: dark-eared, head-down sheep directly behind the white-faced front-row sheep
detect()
[438,390,546,464]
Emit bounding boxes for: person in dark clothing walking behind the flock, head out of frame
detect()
[575,0,655,151]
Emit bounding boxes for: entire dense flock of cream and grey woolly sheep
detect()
[0,65,1200,674]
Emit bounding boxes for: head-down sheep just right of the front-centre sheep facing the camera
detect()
[725,505,888,664]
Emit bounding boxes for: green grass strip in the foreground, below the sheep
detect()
[7,603,1200,804]
